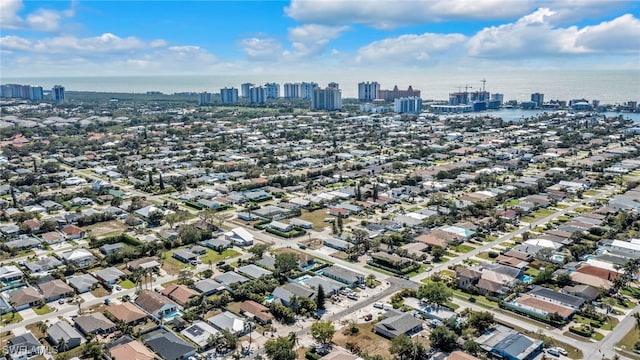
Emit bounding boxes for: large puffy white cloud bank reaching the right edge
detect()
[467,8,640,59]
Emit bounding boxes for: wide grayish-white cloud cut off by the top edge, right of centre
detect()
[285,0,534,29]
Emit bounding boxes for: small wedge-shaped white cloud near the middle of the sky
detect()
[286,24,349,58]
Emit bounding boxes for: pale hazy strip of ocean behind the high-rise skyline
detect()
[0,68,640,104]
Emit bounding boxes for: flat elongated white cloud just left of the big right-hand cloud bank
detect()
[356,33,466,65]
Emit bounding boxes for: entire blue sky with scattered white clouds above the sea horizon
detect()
[0,0,640,77]
